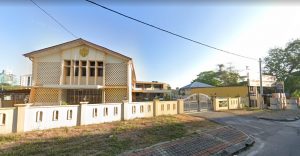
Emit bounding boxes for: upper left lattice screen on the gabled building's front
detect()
[36,62,61,85]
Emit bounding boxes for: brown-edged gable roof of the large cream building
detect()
[23,38,132,60]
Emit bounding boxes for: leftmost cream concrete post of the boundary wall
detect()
[15,103,32,133]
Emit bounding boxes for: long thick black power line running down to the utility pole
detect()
[86,0,257,60]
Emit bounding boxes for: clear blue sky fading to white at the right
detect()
[0,0,300,88]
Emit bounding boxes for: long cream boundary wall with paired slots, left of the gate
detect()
[0,99,184,134]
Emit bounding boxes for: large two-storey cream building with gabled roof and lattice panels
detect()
[24,39,168,105]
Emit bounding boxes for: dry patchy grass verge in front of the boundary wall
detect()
[0,115,221,155]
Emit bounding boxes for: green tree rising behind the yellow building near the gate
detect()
[193,64,240,86]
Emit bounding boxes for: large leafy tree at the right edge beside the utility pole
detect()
[264,39,300,93]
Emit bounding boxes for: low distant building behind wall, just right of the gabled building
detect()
[132,81,171,101]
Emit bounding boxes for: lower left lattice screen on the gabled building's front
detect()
[30,88,60,105]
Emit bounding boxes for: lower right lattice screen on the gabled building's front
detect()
[105,88,128,103]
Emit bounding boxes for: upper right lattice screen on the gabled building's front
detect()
[105,63,127,86]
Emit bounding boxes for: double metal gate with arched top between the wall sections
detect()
[184,94,212,112]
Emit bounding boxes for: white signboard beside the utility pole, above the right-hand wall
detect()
[249,74,276,87]
